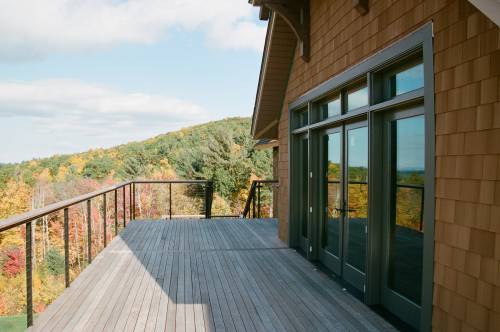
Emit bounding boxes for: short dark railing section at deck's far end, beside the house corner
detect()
[242,180,278,218]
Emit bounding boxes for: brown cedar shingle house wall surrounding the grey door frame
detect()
[278,0,500,331]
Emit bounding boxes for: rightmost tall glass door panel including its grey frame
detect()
[382,109,425,328]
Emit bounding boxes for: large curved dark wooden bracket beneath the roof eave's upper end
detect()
[248,0,311,62]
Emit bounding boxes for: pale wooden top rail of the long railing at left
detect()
[0,180,210,233]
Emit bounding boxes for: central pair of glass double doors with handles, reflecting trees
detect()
[320,122,368,290]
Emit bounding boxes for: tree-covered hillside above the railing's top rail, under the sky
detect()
[0,118,272,218]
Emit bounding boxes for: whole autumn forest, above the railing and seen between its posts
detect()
[0,118,272,330]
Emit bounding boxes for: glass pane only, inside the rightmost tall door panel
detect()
[388,116,425,304]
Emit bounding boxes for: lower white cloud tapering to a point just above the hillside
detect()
[0,80,213,162]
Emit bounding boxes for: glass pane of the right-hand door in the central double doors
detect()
[346,127,368,272]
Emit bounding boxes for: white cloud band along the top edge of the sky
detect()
[0,0,265,60]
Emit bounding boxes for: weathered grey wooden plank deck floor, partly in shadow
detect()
[32,220,393,332]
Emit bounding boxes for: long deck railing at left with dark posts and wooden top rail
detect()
[0,180,213,327]
